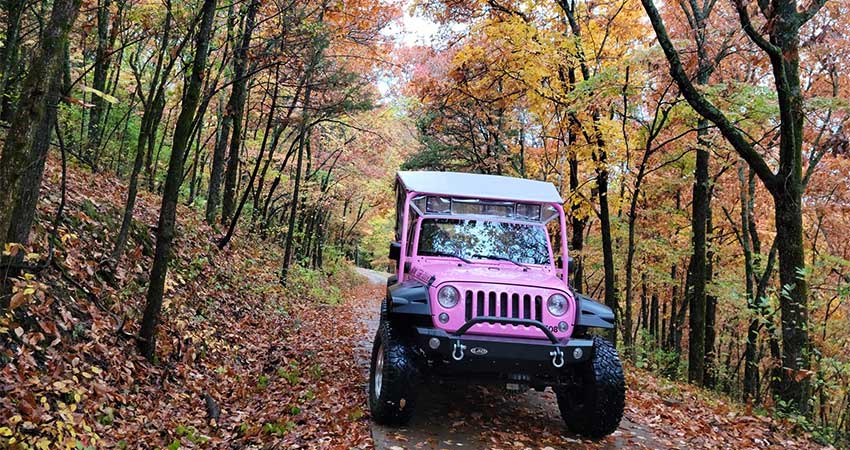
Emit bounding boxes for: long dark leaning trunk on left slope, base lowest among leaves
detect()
[138,0,216,360]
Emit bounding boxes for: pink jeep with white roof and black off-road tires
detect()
[369,172,625,437]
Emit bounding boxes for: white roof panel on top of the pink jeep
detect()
[398,171,564,203]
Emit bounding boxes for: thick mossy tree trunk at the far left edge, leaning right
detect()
[0,0,81,248]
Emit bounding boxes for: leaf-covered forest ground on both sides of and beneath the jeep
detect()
[0,161,836,450]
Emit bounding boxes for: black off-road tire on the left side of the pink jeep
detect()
[369,312,419,425]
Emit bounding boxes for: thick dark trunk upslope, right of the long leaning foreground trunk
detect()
[221,0,260,225]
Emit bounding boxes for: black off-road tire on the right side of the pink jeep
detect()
[555,336,626,439]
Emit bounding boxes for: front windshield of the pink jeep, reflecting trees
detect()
[417,218,549,265]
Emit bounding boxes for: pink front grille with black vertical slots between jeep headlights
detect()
[464,289,543,322]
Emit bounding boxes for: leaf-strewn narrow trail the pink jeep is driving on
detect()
[357,269,668,450]
